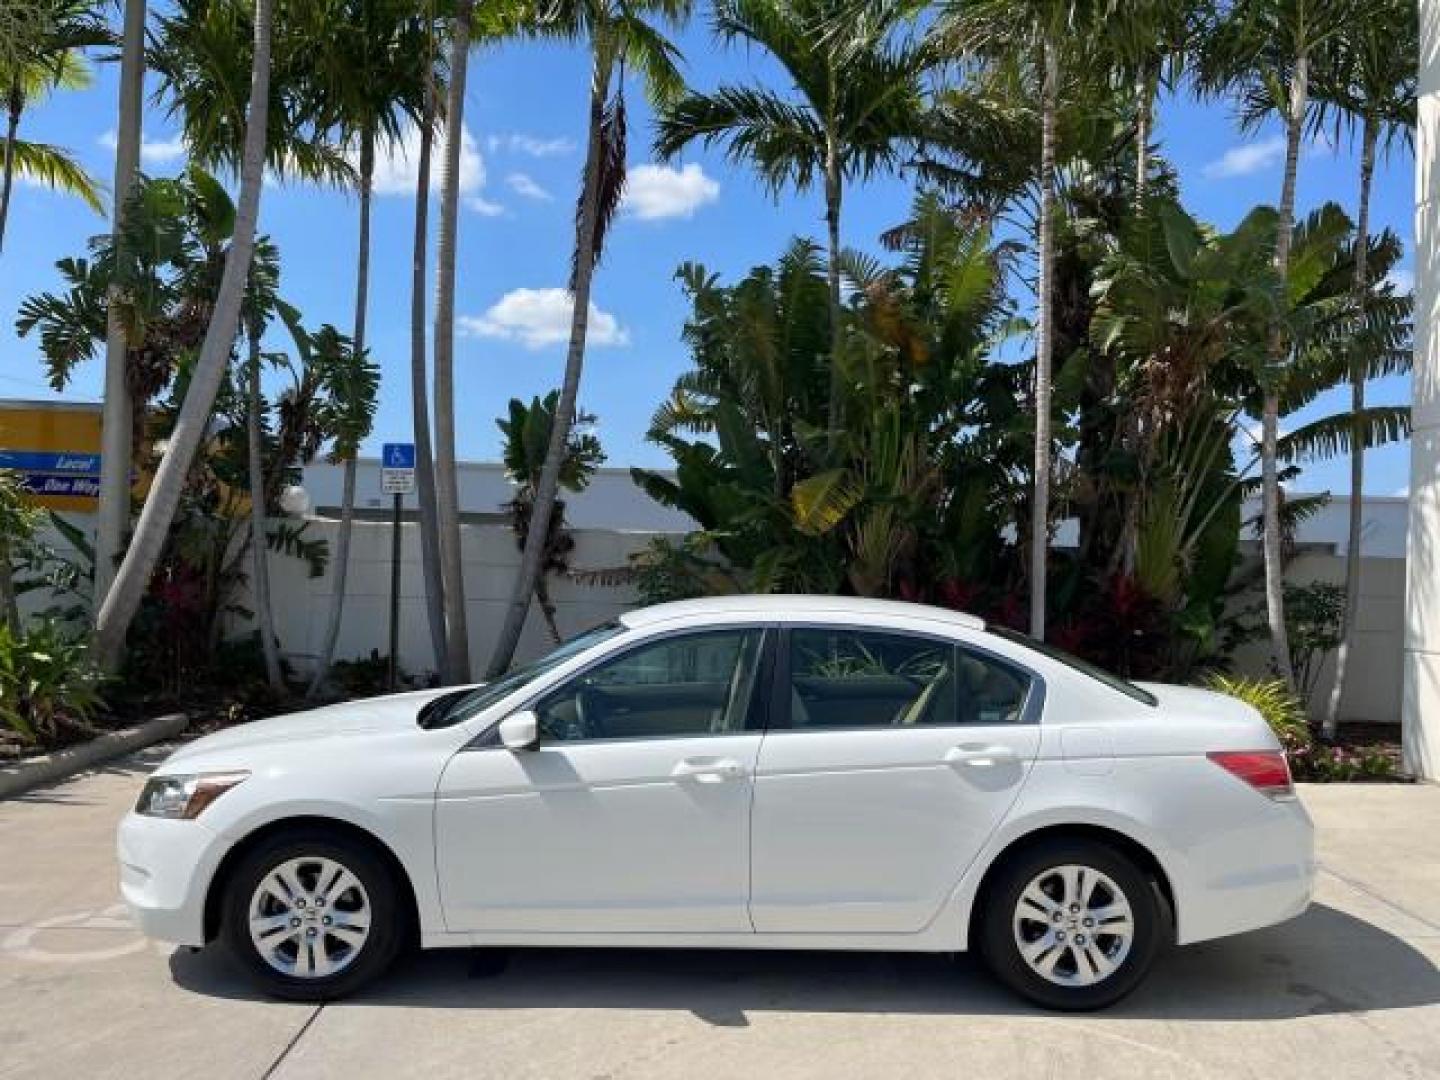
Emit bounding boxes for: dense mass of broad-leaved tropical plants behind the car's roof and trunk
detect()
[636,180,1410,678]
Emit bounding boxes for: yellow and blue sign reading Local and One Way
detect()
[0,399,101,513]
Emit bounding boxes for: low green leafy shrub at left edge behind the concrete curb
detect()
[0,619,104,743]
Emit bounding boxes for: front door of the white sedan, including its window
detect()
[435,629,763,933]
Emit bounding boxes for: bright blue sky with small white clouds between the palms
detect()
[0,20,1414,495]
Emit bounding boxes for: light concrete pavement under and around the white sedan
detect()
[0,753,1440,1080]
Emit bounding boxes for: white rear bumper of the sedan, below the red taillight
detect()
[1179,799,1315,945]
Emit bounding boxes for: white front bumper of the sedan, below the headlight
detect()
[115,811,228,946]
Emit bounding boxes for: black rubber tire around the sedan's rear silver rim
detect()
[976,840,1171,1012]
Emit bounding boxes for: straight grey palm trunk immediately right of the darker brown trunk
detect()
[435,0,475,683]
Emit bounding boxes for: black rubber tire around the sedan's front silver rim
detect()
[220,828,409,1001]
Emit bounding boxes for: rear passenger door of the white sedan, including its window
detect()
[750,626,1044,933]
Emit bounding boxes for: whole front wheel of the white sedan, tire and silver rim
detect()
[220,831,403,1001]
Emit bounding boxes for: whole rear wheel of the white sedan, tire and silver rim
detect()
[979,840,1169,1009]
